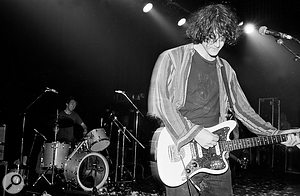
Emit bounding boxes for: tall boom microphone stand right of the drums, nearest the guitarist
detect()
[115,90,145,182]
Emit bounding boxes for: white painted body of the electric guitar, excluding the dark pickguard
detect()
[156,120,236,187]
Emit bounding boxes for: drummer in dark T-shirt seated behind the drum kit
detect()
[56,97,87,147]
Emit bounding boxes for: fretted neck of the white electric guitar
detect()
[219,134,288,151]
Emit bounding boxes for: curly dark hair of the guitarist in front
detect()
[186,4,238,45]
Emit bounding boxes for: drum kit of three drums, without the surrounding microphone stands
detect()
[33,128,110,192]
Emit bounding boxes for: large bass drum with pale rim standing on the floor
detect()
[64,152,109,191]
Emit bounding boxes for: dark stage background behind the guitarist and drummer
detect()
[0,0,300,184]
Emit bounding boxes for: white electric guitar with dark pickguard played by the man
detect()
[151,120,299,187]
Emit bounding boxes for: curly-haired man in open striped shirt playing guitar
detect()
[148,4,300,196]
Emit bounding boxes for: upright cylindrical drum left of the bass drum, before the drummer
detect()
[43,142,71,169]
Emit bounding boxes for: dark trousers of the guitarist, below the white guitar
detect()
[166,169,233,196]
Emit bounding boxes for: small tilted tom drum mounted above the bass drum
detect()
[87,128,110,152]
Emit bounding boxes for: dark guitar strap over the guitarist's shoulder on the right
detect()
[219,59,238,139]
